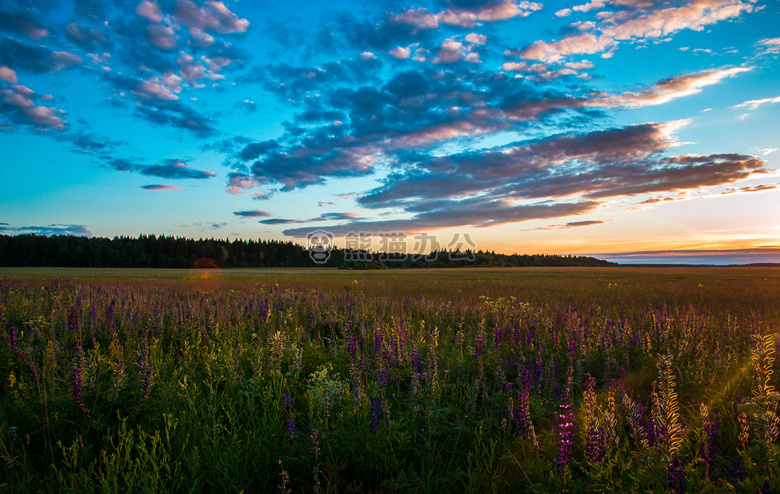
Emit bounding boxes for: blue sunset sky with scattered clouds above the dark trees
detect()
[0,0,780,264]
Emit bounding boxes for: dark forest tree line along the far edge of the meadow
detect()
[0,234,614,269]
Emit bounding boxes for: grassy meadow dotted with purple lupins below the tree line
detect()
[0,267,780,493]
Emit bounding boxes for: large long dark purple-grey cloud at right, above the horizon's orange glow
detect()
[358,123,765,212]
